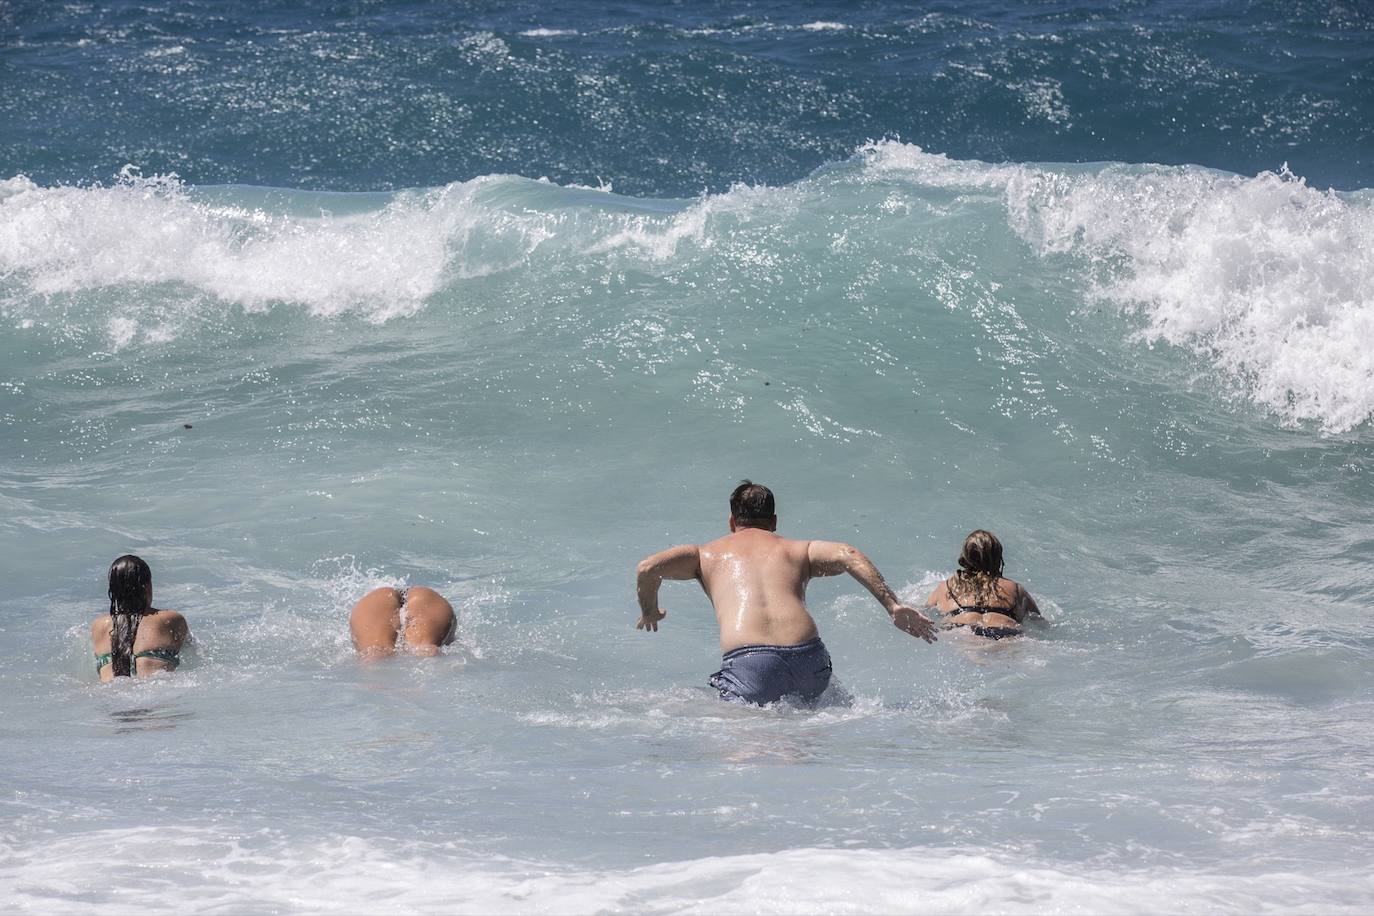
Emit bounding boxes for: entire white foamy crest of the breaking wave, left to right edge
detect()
[0,141,1374,433]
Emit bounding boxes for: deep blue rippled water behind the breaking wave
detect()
[0,0,1374,196]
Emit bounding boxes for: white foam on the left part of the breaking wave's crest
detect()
[0,174,540,335]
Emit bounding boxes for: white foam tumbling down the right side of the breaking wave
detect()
[860,141,1374,433]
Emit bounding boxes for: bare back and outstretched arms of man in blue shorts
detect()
[635,516,936,652]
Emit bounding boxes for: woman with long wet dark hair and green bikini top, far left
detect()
[91,553,191,681]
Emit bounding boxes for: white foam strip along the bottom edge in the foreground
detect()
[0,825,1374,913]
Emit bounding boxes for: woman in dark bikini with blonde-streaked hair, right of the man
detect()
[926,529,1041,640]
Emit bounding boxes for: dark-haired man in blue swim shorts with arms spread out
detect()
[635,481,936,706]
